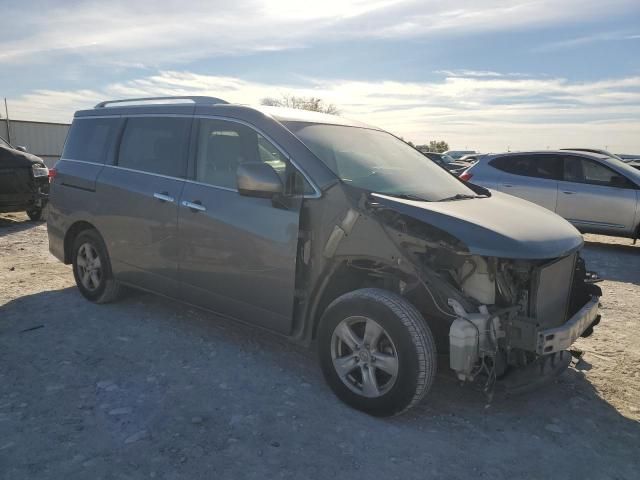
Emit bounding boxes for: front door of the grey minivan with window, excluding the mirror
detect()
[179,119,301,334]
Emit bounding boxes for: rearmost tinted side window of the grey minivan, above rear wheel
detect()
[62,118,120,163]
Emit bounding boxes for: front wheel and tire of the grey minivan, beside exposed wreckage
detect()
[318,288,437,417]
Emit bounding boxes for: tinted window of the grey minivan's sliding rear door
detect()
[118,117,191,178]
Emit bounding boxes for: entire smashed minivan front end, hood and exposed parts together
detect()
[362,190,601,393]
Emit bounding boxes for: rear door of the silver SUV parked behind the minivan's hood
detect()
[490,154,562,211]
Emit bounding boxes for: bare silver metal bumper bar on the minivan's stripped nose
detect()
[536,296,600,355]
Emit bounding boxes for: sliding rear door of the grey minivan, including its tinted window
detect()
[97,116,192,296]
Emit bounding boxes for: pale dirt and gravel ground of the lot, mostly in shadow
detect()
[0,215,640,480]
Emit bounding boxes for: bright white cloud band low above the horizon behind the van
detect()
[9,71,640,151]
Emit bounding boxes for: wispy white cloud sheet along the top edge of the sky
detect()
[0,0,637,68]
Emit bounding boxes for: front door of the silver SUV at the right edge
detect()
[558,155,637,235]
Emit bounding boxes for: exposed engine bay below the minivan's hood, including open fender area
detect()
[372,202,601,391]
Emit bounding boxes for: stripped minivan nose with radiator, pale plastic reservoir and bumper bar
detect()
[449,253,601,390]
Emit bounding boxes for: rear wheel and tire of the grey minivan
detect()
[71,229,121,303]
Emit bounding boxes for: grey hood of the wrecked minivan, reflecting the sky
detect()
[371,190,583,260]
